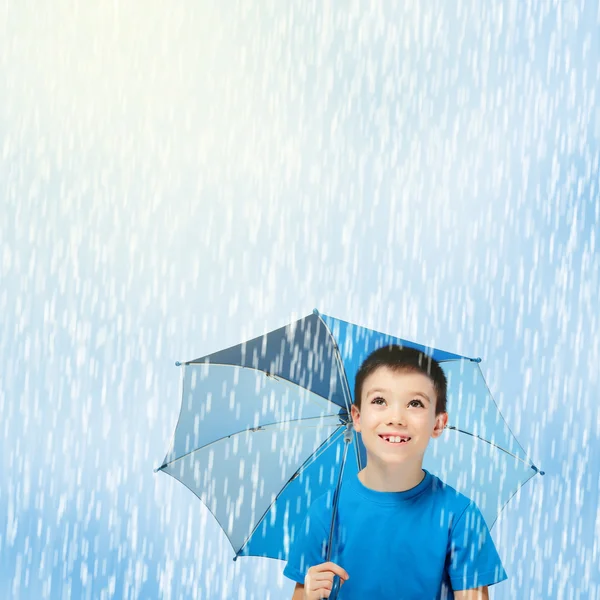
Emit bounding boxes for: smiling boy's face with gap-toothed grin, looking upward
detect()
[352,367,448,466]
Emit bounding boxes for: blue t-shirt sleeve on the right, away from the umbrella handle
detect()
[448,502,508,590]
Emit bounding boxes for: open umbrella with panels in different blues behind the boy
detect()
[157,310,543,592]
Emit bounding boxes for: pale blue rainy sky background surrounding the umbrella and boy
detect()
[0,0,600,600]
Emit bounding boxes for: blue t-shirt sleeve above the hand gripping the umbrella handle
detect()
[283,505,329,583]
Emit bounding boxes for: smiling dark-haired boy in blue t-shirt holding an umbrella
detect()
[284,345,507,600]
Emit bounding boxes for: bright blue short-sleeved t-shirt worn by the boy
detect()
[283,471,507,600]
